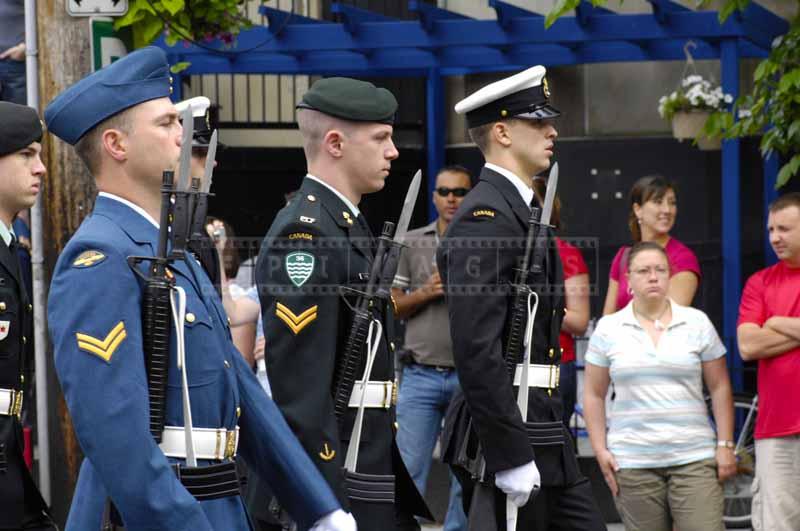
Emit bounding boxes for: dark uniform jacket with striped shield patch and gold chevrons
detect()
[256,178,427,529]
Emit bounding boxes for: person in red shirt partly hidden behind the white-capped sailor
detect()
[533,179,590,428]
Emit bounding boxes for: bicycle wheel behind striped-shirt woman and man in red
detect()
[708,395,758,529]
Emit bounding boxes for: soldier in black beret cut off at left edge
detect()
[0,102,56,531]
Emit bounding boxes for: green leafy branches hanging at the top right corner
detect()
[545,0,800,187]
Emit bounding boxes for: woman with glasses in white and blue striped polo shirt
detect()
[583,242,736,531]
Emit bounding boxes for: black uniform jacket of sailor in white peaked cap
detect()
[437,168,578,486]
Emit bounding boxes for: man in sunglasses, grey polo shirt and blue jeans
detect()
[392,166,472,531]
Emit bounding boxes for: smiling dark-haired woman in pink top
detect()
[603,175,700,315]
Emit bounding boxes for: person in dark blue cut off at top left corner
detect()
[0,0,28,105]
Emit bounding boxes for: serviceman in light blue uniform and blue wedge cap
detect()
[45,47,355,531]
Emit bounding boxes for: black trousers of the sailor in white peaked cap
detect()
[452,467,606,531]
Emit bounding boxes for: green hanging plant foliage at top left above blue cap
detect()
[114,0,251,48]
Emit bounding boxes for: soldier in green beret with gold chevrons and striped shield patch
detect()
[256,78,428,531]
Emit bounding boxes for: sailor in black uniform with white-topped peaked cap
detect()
[437,66,605,531]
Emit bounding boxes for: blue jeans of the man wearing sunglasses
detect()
[397,364,467,531]
